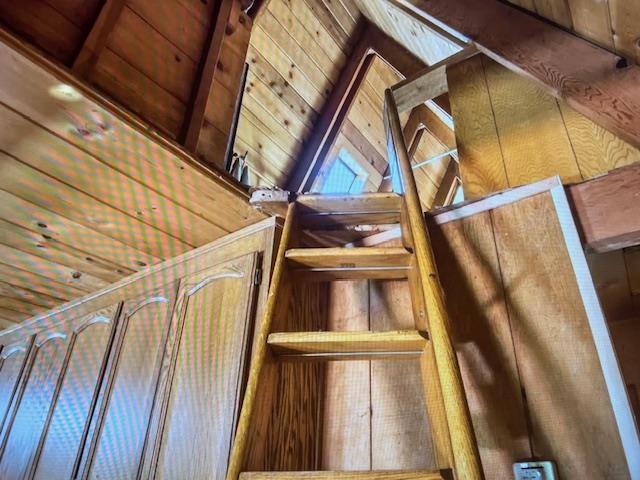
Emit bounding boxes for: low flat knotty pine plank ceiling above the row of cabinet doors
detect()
[0,33,263,322]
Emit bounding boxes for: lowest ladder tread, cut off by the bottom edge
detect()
[240,470,448,480]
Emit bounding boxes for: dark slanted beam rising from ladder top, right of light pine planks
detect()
[286,25,374,193]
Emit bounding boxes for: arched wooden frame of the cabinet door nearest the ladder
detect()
[147,252,262,478]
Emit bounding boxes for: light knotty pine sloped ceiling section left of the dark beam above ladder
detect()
[234,0,362,186]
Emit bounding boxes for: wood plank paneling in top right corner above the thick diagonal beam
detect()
[509,0,640,63]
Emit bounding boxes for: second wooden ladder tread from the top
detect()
[285,247,411,280]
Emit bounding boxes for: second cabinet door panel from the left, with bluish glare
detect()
[0,332,69,480]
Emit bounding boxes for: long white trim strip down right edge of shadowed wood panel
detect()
[550,185,640,480]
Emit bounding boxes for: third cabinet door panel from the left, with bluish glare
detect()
[33,305,118,480]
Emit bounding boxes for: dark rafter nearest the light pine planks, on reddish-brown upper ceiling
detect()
[181,0,239,152]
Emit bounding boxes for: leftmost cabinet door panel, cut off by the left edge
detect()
[0,335,33,445]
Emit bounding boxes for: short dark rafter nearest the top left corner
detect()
[71,0,126,77]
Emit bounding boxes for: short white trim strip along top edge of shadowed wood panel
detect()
[427,176,562,225]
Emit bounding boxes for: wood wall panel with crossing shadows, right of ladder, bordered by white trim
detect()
[429,193,629,479]
